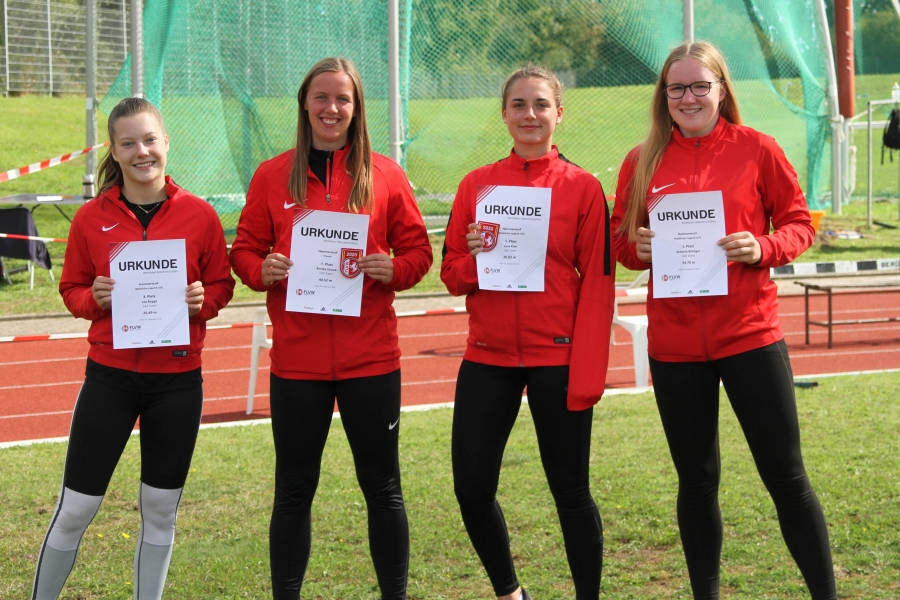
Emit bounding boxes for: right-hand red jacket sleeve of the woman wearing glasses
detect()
[754,135,816,268]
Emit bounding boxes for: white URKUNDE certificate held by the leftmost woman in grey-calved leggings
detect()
[109,240,191,349]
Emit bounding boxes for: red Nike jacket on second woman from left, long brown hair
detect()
[231,150,433,380]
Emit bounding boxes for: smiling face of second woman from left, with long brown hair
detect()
[303,71,356,150]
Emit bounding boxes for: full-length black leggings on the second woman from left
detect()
[269,369,409,600]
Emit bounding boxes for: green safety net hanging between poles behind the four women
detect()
[100,0,900,231]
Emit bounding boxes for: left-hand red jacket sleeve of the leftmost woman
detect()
[59,211,109,321]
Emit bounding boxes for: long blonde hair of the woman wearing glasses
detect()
[618,42,743,241]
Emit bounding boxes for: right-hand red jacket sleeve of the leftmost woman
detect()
[190,202,234,323]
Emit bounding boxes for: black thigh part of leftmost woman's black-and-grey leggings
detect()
[63,374,203,496]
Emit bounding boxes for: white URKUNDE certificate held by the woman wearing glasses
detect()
[647,191,728,298]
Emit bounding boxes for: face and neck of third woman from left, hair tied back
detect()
[502,77,563,159]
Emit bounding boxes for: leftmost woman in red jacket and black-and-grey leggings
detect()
[31,98,234,600]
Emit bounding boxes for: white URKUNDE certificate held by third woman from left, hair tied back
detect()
[475,185,550,292]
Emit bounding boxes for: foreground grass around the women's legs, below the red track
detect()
[0,373,900,600]
